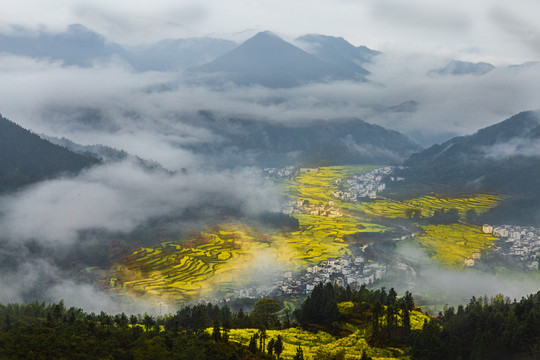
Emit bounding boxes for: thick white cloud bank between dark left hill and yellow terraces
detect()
[0,160,279,244]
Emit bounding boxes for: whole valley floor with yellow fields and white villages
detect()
[106,166,524,305]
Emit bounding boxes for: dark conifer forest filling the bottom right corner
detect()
[411,291,540,360]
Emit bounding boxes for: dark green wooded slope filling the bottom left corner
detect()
[0,314,265,360]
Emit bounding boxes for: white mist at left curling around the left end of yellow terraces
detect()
[0,158,281,313]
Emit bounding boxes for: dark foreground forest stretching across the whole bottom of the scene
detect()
[0,283,540,360]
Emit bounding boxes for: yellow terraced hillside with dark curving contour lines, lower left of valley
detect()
[116,231,251,301]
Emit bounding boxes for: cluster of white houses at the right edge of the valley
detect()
[482,224,540,271]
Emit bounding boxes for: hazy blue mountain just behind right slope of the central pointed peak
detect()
[296,34,380,75]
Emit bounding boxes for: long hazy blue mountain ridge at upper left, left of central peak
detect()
[0,24,236,71]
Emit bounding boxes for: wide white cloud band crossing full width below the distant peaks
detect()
[0,52,540,148]
